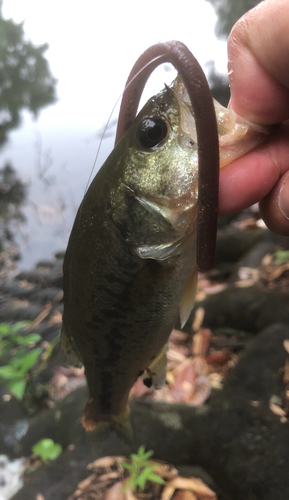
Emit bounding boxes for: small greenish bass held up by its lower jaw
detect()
[61,76,267,438]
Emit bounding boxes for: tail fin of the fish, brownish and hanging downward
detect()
[81,399,134,444]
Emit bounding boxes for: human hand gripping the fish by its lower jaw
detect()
[219,0,289,235]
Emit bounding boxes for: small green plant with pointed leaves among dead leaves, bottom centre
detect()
[121,446,165,492]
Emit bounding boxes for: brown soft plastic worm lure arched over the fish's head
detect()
[115,40,219,271]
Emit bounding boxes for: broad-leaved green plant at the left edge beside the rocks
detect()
[0,321,42,399]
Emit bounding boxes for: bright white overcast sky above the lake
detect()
[3,0,226,131]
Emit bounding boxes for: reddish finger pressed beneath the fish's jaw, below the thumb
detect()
[219,122,289,215]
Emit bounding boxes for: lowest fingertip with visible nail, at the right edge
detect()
[259,172,289,236]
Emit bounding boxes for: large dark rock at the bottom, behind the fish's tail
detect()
[7,325,289,500]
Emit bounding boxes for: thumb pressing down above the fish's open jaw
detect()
[228,0,289,124]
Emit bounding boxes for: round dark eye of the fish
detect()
[137,116,168,149]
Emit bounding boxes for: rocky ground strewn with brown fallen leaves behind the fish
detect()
[0,213,289,500]
